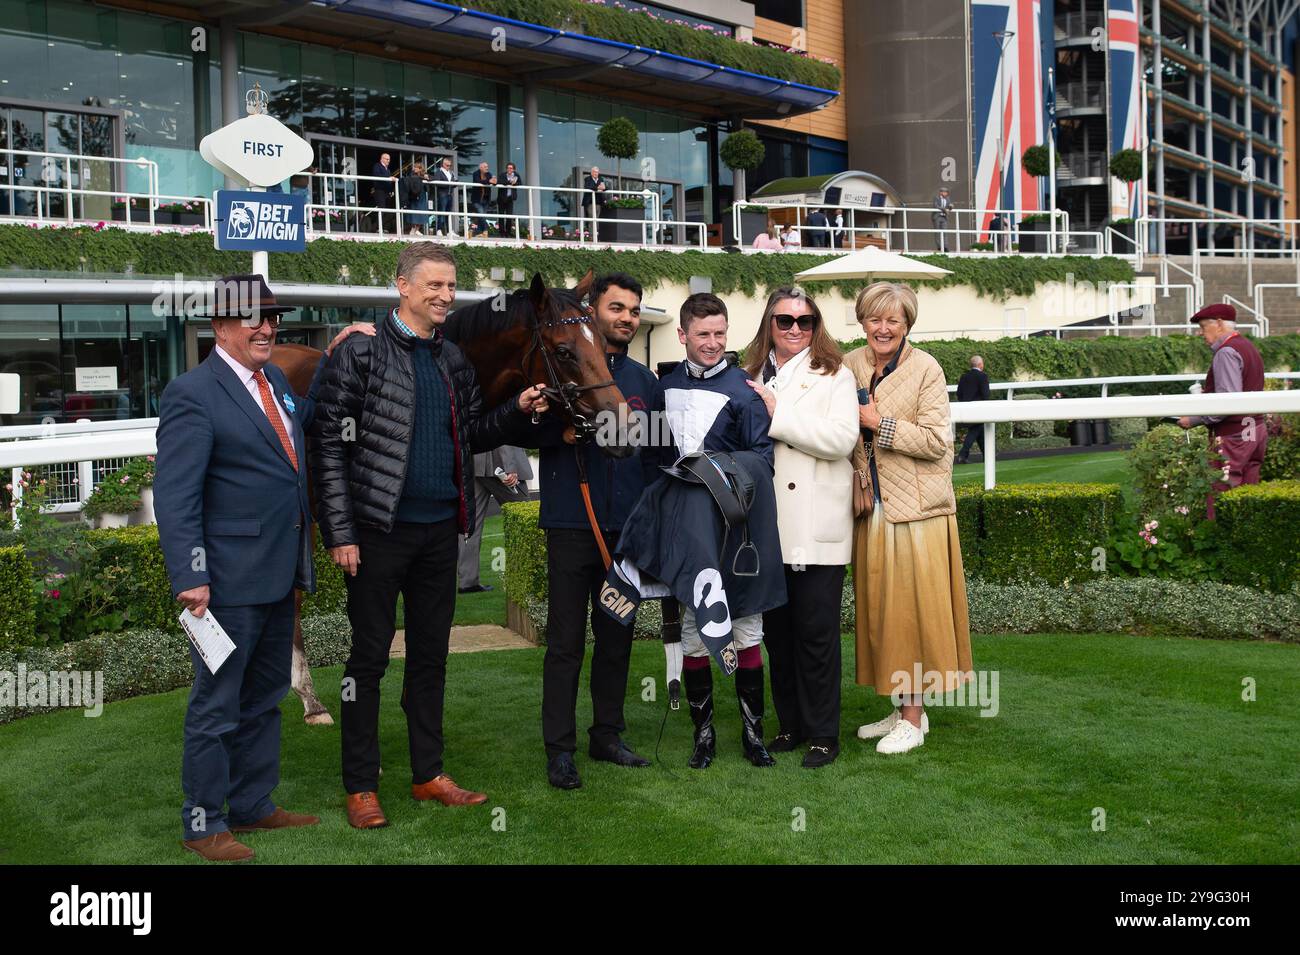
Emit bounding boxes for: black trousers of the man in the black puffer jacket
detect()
[339,518,458,793]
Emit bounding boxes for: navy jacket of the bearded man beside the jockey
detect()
[508,350,663,541]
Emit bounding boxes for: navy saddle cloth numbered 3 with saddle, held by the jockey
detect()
[601,451,787,674]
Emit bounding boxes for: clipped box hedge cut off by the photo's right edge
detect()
[1214,481,1300,591]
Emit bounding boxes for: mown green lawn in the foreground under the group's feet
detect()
[0,634,1300,864]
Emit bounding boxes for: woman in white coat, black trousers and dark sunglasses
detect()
[745,287,858,768]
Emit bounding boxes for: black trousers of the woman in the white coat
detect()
[763,564,844,739]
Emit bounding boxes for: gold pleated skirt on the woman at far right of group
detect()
[853,502,971,696]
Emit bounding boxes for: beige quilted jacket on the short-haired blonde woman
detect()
[844,342,957,524]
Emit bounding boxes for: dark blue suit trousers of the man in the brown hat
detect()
[181,590,294,839]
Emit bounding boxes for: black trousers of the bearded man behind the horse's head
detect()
[542,529,632,756]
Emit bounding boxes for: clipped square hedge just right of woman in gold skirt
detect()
[962,483,1123,583]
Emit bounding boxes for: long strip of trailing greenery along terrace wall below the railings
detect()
[0,225,1133,302]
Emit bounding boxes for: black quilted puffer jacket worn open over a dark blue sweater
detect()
[311,315,527,547]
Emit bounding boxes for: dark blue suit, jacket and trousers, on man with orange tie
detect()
[153,351,316,839]
